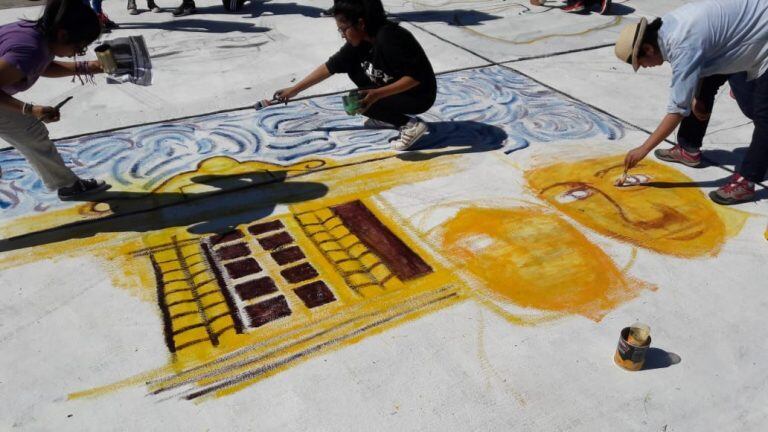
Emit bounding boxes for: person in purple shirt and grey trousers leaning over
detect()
[0,0,109,200]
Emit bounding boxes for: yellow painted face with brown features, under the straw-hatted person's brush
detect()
[525,156,726,258]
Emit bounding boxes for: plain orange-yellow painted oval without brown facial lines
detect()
[442,208,644,321]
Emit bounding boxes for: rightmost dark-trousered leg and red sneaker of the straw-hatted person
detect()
[709,74,768,204]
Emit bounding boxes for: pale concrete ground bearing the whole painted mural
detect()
[0,0,768,431]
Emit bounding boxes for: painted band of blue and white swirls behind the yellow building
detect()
[0,66,624,221]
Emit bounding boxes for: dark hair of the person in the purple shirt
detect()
[32,0,101,45]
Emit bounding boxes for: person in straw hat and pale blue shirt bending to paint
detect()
[615,0,768,204]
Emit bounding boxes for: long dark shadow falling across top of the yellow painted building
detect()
[0,171,328,252]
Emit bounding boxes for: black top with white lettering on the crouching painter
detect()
[325,23,437,95]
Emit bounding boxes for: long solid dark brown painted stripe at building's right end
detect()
[332,201,432,280]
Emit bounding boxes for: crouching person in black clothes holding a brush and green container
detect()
[274,0,437,150]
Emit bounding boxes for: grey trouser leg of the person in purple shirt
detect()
[0,110,78,190]
